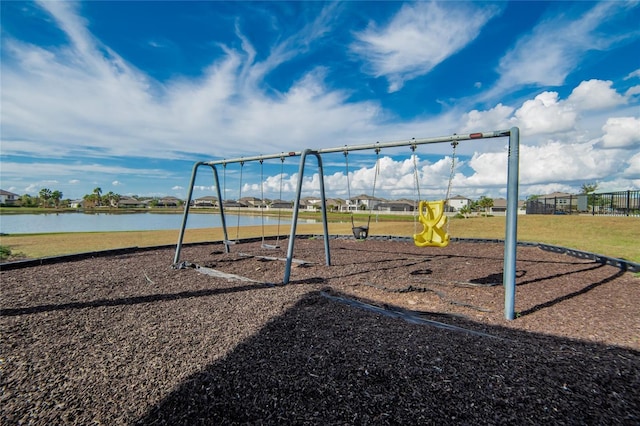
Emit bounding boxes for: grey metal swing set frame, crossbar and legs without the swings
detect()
[173,127,520,320]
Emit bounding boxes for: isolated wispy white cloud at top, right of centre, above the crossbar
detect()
[351,2,499,92]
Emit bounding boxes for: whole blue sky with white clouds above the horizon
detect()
[0,1,640,199]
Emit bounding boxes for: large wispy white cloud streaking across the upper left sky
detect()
[2,2,381,158]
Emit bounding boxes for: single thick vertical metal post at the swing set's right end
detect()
[502,127,520,320]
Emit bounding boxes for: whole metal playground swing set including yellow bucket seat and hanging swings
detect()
[173,127,520,320]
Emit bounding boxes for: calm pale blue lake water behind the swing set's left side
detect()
[0,212,302,234]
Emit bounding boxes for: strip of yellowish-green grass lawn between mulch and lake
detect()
[0,215,640,263]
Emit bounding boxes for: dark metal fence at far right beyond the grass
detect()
[527,190,640,217]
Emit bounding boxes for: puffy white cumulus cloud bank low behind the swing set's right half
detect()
[225,75,640,199]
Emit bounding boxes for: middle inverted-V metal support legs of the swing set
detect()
[282,149,331,284]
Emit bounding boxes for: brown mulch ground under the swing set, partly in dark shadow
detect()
[0,239,640,425]
